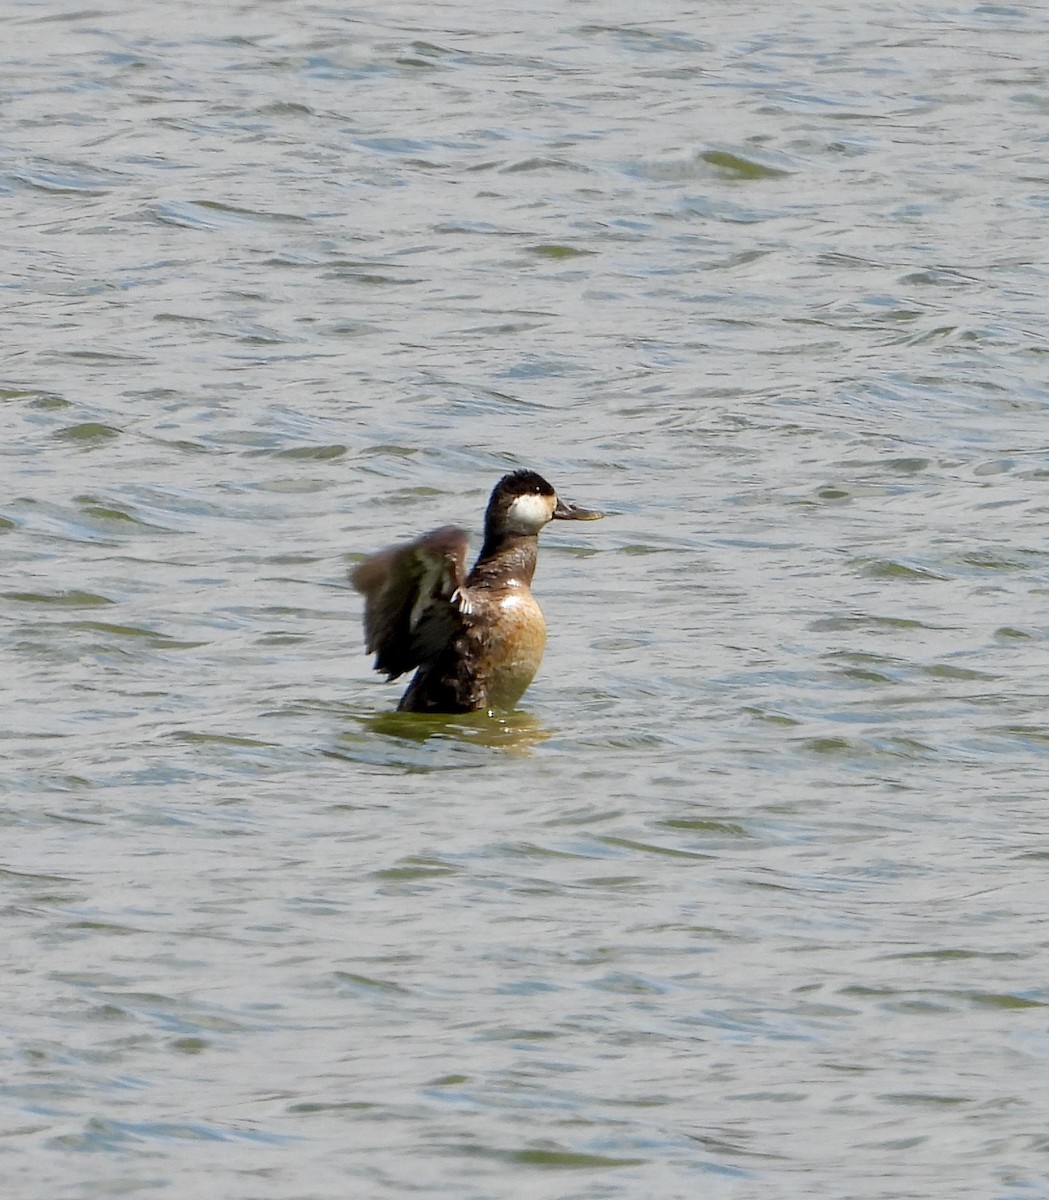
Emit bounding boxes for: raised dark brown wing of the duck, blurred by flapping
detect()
[349,526,468,679]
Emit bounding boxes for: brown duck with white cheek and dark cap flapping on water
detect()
[350,470,604,713]
